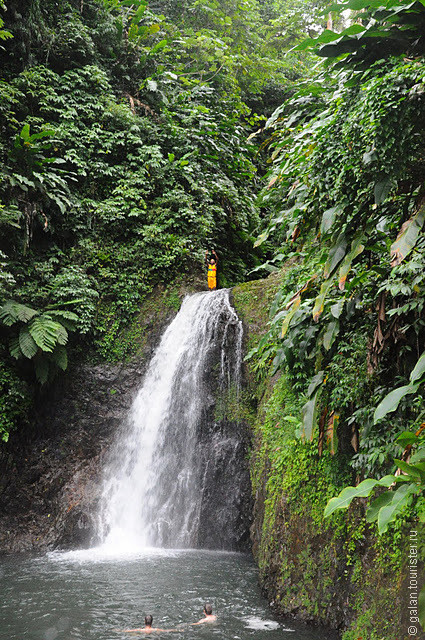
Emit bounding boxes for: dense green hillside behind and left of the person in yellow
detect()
[0,0,314,439]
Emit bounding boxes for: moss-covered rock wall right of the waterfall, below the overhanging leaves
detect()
[233,272,425,640]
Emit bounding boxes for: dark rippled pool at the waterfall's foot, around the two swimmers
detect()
[0,550,334,640]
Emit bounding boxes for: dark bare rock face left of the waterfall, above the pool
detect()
[0,365,143,551]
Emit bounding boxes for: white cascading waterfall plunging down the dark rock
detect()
[96,290,242,550]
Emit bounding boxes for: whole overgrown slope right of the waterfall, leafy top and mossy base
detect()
[234,2,425,640]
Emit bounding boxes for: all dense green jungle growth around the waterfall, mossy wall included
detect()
[0,0,425,640]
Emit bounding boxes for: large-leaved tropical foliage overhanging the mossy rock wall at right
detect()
[248,0,425,622]
